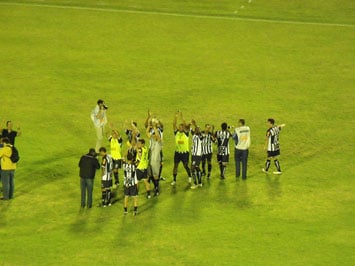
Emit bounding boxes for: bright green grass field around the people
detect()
[0,0,355,265]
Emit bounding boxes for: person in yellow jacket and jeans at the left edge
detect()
[0,137,16,200]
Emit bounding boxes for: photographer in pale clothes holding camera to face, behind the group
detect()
[91,99,108,152]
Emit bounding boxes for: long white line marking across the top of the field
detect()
[0,2,355,28]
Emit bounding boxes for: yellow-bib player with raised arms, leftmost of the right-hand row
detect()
[171,111,191,186]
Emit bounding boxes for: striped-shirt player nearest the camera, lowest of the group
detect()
[123,153,138,215]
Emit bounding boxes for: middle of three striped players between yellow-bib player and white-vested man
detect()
[202,124,216,179]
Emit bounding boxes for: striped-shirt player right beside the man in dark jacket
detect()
[99,147,113,207]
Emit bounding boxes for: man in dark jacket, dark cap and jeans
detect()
[79,148,100,208]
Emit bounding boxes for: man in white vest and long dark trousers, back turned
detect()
[233,119,250,180]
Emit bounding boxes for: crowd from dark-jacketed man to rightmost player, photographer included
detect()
[79,100,284,215]
